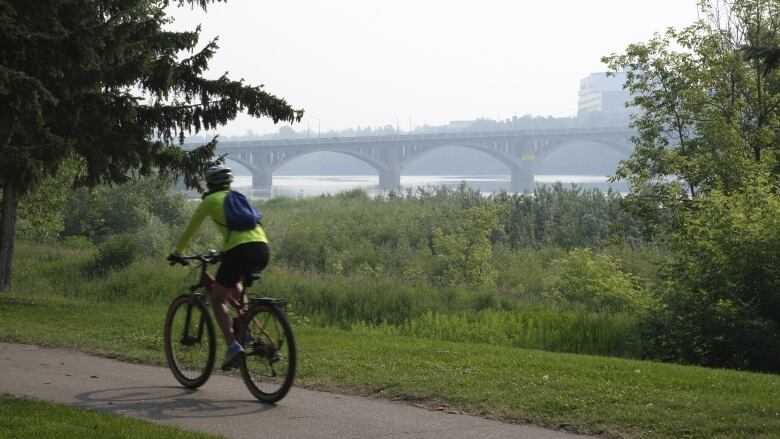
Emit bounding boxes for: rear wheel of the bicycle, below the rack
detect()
[236,303,296,403]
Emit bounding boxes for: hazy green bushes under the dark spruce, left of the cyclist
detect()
[14,177,204,273]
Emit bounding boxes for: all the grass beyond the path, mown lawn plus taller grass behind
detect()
[6,243,780,438]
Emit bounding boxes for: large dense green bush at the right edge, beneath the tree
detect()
[646,181,780,372]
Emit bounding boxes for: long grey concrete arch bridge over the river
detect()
[193,127,635,192]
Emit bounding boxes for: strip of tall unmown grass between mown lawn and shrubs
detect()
[12,242,641,358]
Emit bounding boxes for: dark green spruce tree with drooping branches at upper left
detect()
[0,0,303,289]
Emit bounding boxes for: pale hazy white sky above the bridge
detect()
[171,0,697,135]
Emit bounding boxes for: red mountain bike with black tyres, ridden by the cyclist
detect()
[163,251,296,403]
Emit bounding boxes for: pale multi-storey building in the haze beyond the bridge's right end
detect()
[577,72,631,126]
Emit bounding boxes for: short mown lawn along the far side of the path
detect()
[0,293,780,438]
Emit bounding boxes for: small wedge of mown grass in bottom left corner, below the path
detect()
[0,395,216,439]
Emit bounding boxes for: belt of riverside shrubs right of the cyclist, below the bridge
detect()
[261,185,650,291]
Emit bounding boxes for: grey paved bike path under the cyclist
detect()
[0,343,582,439]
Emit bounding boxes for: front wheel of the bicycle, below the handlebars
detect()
[163,294,217,389]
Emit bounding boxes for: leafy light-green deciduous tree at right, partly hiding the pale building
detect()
[603,0,780,227]
